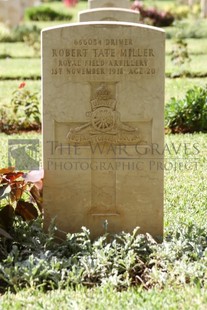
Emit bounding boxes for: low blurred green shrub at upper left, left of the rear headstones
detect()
[25,6,72,21]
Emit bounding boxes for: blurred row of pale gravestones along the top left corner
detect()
[0,0,40,27]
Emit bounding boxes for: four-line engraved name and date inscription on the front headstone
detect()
[51,39,157,80]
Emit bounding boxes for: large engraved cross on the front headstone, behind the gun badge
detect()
[54,83,151,216]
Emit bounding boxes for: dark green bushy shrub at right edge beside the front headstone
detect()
[165,86,207,133]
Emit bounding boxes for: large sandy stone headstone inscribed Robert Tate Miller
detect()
[42,22,165,238]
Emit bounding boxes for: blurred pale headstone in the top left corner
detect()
[0,0,22,27]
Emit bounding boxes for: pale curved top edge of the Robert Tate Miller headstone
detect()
[41,21,165,33]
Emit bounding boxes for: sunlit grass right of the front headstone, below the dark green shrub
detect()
[165,134,207,230]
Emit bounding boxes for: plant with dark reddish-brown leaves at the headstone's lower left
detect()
[0,167,43,239]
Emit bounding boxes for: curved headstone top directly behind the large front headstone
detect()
[79,8,139,23]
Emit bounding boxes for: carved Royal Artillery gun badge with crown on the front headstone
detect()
[67,83,140,144]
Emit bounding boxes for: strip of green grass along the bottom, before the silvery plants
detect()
[0,287,207,310]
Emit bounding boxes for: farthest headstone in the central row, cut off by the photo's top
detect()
[88,0,131,9]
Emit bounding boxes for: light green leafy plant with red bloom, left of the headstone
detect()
[0,82,41,132]
